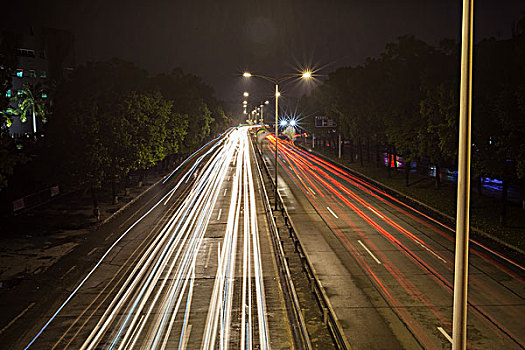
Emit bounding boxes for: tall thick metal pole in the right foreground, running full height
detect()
[452,0,474,350]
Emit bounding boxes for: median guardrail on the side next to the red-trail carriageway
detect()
[255,139,351,350]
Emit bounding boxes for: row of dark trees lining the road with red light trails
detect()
[301,19,525,215]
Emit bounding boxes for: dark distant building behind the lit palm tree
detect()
[1,28,75,136]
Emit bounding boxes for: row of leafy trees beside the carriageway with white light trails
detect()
[0,59,230,215]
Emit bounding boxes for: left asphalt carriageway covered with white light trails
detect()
[0,128,293,349]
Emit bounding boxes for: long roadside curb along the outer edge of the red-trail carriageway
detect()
[298,145,525,255]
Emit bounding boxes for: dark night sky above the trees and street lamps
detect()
[2,0,525,101]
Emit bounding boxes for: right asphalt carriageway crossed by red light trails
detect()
[264,136,525,349]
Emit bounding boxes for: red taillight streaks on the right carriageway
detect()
[267,135,525,349]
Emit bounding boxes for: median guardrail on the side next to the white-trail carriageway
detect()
[252,138,313,350]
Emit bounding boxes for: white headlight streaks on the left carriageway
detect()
[26,128,270,350]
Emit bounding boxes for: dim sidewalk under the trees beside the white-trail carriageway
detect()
[0,171,165,292]
